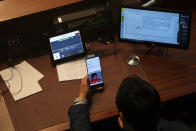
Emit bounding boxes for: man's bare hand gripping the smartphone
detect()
[78,75,90,98]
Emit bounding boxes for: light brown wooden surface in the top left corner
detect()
[0,0,83,22]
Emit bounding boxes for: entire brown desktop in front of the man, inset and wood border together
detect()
[0,7,196,131]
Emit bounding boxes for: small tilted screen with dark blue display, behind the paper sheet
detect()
[49,30,84,61]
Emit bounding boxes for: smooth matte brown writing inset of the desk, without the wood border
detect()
[0,42,148,131]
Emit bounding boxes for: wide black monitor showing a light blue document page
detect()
[120,7,191,49]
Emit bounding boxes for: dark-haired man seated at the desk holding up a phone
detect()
[69,76,190,131]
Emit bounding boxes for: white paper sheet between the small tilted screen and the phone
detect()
[56,59,87,81]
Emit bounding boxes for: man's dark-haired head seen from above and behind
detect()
[116,76,160,131]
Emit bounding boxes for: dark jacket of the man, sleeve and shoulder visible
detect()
[69,104,190,131]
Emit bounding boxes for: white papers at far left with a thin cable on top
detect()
[0,61,44,101]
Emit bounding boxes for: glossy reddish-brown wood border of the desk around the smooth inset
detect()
[41,10,196,131]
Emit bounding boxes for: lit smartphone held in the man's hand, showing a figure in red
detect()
[86,56,104,88]
